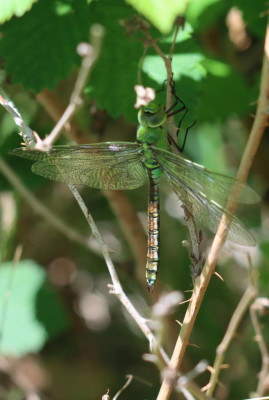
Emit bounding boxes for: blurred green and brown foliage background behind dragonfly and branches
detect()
[0,0,269,400]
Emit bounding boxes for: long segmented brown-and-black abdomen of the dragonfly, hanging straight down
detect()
[146,170,160,291]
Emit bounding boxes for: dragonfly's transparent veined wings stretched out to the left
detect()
[10,142,147,190]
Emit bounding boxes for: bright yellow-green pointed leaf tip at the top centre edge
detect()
[126,0,188,34]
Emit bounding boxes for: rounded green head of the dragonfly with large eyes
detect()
[138,103,167,128]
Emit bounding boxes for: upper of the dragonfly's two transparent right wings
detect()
[151,148,260,206]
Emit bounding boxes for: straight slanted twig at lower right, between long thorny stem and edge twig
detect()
[206,286,258,396]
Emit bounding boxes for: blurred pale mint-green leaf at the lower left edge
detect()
[0,260,67,356]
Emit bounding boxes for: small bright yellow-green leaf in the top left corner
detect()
[0,0,37,24]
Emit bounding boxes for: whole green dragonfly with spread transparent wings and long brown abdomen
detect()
[10,97,259,291]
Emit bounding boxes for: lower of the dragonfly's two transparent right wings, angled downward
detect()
[154,150,256,246]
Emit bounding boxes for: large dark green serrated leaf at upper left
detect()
[0,0,89,93]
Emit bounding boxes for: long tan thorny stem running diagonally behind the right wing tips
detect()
[157,14,269,400]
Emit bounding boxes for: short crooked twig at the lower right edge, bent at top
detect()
[250,298,269,396]
